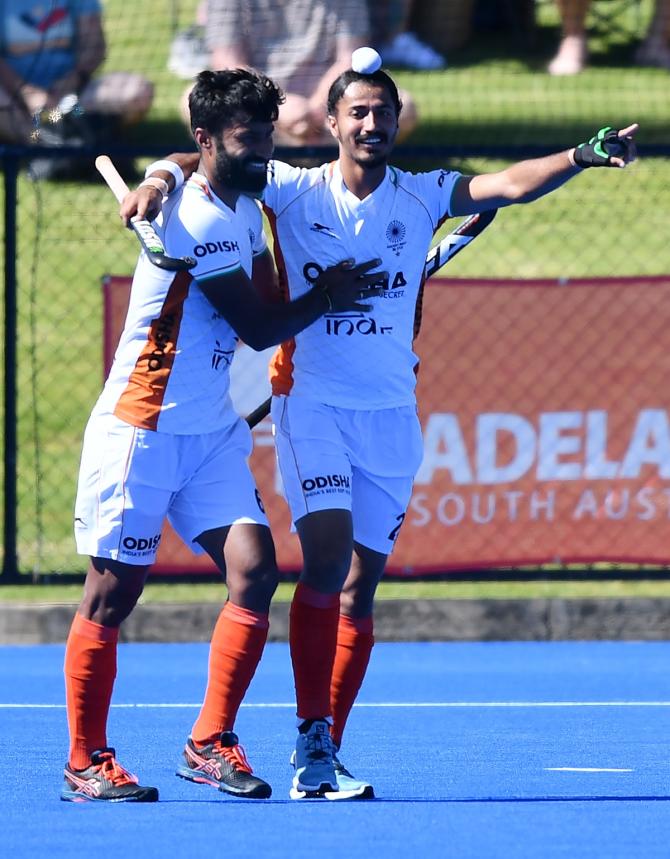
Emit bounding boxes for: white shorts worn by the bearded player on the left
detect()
[74,415,268,564]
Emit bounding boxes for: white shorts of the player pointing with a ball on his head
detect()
[272,396,423,555]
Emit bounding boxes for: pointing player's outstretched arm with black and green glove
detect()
[451,124,638,215]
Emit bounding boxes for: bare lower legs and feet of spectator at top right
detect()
[548,0,670,75]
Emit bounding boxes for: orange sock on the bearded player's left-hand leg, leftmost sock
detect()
[65,614,119,770]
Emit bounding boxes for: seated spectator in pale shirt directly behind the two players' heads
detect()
[177,0,417,146]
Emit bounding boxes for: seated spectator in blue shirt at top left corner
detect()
[0,0,153,145]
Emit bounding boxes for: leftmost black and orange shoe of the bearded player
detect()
[60,749,158,802]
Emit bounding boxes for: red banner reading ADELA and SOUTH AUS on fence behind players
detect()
[105,276,670,575]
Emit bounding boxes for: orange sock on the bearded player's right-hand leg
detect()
[191,602,270,746]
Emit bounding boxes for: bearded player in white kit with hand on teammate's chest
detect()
[61,69,380,802]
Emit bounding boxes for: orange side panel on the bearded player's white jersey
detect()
[114,271,193,430]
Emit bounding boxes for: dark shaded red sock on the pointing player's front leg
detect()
[289,582,340,719]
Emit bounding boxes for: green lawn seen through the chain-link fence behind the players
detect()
[1,0,670,573]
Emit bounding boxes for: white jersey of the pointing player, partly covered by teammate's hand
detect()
[263,161,461,409]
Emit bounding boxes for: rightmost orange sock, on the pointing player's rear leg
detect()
[330,614,375,749]
